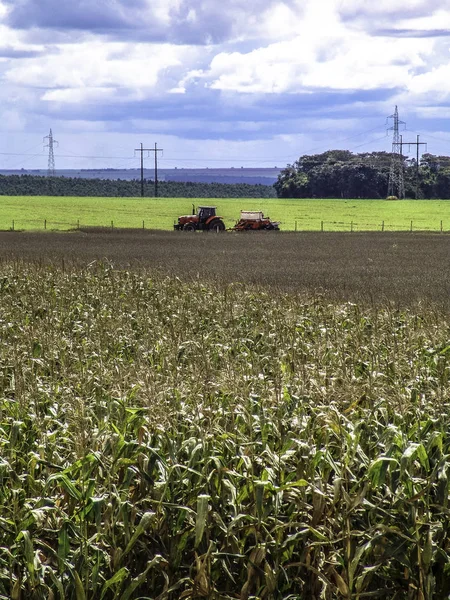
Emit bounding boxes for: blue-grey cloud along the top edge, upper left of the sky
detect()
[4,0,284,45]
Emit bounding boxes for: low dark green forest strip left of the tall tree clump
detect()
[0,175,276,198]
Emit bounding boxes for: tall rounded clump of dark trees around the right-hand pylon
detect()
[274,150,450,198]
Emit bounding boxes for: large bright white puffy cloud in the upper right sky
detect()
[191,27,433,93]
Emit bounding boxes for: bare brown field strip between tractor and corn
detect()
[0,229,450,308]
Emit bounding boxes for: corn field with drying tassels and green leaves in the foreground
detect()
[0,262,450,600]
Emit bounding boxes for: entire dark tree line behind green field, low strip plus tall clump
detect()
[0,150,450,198]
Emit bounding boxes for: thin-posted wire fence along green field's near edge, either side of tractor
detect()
[0,219,450,233]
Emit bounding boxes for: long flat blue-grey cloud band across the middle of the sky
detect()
[36,90,395,141]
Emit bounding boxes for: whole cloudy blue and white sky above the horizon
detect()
[0,0,450,169]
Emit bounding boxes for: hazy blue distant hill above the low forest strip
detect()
[0,167,282,185]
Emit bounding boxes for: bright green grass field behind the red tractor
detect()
[0,196,450,231]
